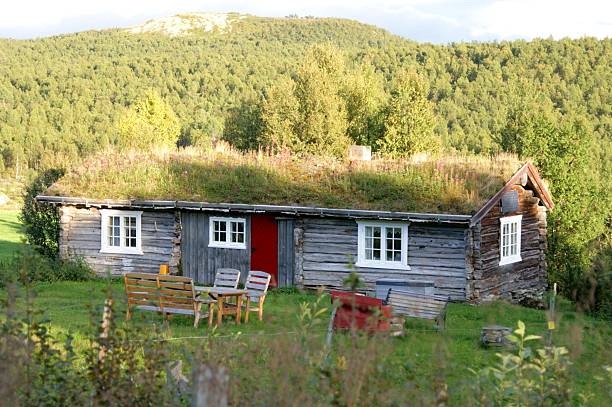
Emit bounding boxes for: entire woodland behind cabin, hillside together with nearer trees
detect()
[0,14,612,315]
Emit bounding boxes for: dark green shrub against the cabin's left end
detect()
[19,169,64,258]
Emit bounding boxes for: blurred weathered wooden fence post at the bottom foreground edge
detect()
[191,363,229,407]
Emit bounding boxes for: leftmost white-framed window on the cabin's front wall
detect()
[100,209,142,254]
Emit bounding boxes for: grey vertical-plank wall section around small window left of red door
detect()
[181,211,251,284]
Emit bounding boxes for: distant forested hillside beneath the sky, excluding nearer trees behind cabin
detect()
[0,13,612,173]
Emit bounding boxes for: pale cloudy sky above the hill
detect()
[0,0,612,43]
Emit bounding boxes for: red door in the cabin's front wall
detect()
[251,215,278,287]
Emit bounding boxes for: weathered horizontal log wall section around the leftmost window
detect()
[59,206,181,275]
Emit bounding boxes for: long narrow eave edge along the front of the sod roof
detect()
[36,195,472,225]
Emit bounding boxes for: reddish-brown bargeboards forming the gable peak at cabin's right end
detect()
[470,162,555,226]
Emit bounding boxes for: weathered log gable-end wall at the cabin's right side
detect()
[468,185,546,305]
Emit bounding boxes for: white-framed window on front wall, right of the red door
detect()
[355,221,410,270]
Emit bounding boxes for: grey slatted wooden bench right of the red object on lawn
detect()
[387,288,449,328]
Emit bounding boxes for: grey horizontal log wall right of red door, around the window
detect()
[294,218,467,300]
